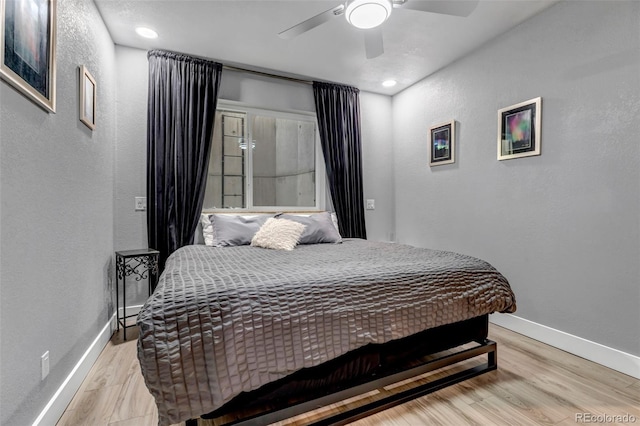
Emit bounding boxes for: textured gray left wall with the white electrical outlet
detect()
[0,0,116,426]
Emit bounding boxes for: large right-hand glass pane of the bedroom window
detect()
[252,115,316,207]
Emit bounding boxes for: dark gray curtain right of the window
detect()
[313,81,367,238]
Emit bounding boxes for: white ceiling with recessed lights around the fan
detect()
[95,0,557,95]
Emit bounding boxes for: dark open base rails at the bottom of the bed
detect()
[194,339,498,426]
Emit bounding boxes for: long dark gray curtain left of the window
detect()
[147,50,222,271]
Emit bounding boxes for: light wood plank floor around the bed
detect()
[58,324,640,426]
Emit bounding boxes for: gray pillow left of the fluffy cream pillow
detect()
[209,214,273,247]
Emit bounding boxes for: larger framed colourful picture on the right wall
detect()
[498,98,542,160]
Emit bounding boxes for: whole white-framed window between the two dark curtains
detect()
[203,102,325,211]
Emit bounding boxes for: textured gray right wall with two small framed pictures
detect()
[393,1,640,355]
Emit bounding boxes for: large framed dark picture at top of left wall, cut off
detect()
[0,0,56,112]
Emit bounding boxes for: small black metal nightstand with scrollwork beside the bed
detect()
[116,249,160,340]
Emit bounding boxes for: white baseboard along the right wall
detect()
[489,314,640,379]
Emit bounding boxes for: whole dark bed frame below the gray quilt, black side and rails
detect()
[186,315,497,426]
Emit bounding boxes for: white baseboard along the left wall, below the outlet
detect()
[33,314,116,426]
